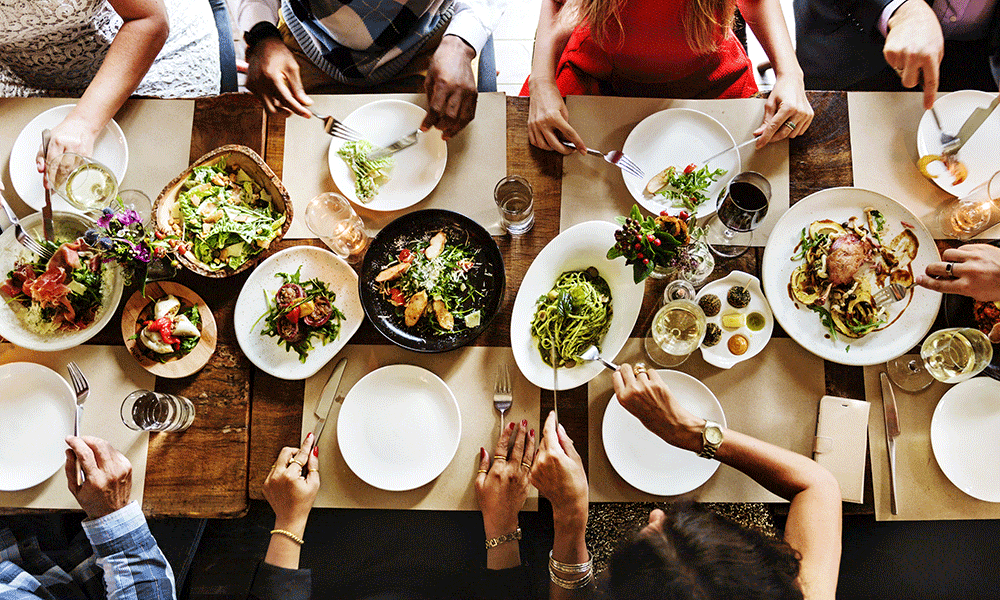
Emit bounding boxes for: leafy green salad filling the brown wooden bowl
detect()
[175,157,285,270]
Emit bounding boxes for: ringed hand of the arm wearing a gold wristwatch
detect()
[611,364,705,452]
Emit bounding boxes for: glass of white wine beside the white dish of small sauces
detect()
[643,281,705,367]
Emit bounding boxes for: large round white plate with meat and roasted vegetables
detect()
[762,188,941,365]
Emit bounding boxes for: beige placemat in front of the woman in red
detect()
[559,96,788,241]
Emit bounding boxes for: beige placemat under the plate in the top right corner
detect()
[847,92,1000,238]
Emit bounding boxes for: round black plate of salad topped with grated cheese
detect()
[358,209,507,352]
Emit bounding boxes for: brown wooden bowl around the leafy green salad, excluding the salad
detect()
[153,144,292,278]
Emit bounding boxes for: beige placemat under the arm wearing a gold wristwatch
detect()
[587,338,825,502]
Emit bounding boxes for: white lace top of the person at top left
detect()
[0,0,220,98]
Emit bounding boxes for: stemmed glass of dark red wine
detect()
[705,171,771,258]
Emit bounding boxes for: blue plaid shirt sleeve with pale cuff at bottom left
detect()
[83,501,177,600]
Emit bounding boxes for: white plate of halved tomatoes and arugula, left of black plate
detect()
[234,246,364,380]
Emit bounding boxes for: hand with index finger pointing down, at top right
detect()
[882,2,944,110]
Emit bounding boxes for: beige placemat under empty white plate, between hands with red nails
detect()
[302,345,541,510]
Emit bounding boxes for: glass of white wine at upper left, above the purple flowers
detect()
[46,152,118,212]
